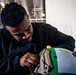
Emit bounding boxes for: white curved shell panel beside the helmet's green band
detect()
[50,48,76,75]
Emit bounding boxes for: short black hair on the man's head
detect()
[1,2,27,27]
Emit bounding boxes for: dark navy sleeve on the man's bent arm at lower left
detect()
[0,44,34,74]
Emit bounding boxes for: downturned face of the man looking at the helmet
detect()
[6,16,33,43]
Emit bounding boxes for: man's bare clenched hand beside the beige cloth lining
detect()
[20,53,39,67]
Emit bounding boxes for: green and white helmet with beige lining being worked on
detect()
[31,47,76,75]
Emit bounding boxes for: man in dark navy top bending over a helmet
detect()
[0,2,75,75]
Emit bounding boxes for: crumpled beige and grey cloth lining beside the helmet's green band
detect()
[34,48,53,75]
